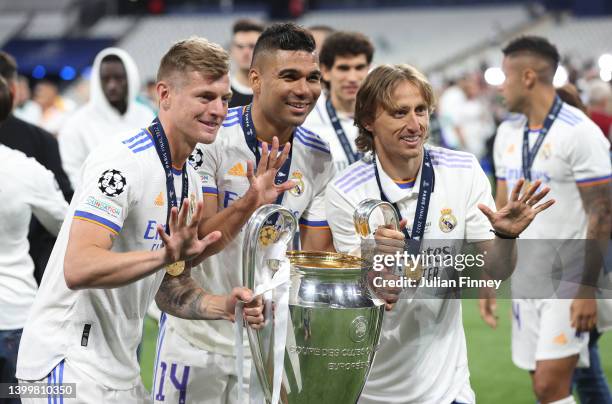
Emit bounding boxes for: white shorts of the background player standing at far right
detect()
[512,299,589,370]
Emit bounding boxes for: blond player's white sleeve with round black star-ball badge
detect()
[74,145,143,234]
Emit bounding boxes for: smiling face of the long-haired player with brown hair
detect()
[366,80,429,161]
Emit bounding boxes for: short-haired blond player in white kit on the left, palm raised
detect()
[17,38,280,404]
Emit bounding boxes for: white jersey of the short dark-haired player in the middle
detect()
[168,107,333,355]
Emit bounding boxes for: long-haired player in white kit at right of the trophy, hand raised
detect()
[326,65,553,404]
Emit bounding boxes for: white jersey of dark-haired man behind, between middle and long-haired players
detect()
[302,94,359,172]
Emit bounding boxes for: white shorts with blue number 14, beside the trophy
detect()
[153,323,251,404]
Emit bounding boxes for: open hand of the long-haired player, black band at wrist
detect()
[478,179,555,237]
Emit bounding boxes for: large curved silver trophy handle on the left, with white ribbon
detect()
[242,205,298,400]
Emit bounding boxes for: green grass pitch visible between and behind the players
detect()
[141,300,612,404]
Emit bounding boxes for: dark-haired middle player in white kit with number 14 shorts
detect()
[154,24,333,404]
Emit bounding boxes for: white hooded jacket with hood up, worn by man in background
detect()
[58,48,155,189]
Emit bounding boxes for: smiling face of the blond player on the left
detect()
[157,71,231,146]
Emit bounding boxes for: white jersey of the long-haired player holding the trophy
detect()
[326,146,495,404]
